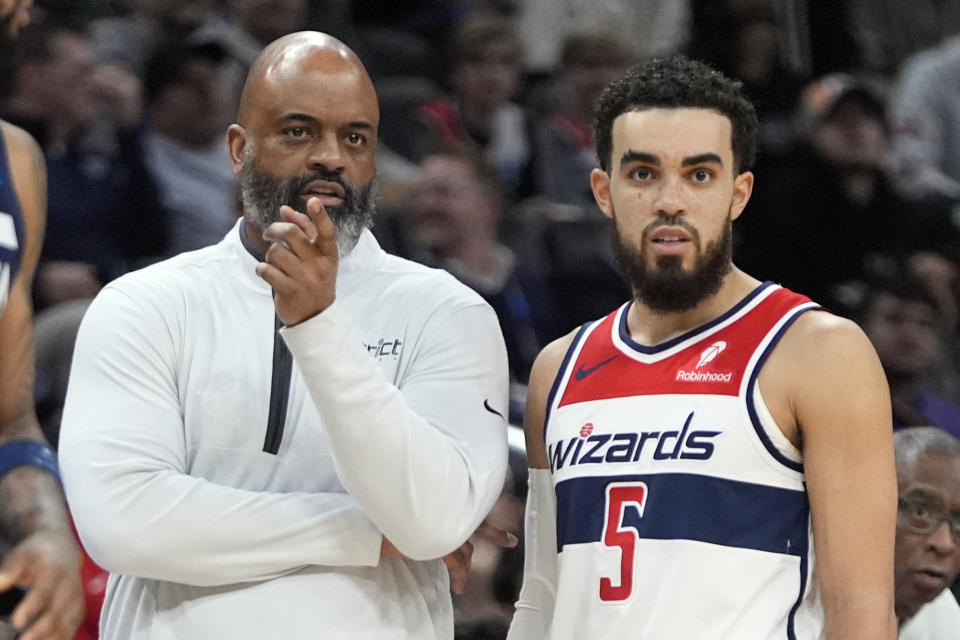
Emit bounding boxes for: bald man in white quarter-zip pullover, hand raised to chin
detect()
[61,32,507,640]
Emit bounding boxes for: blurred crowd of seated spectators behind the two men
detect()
[0,0,960,640]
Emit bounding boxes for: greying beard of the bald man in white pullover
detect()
[240,156,377,256]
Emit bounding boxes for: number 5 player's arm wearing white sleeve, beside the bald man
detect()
[507,332,576,640]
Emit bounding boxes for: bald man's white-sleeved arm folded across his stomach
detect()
[60,282,382,586]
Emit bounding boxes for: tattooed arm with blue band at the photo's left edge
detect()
[0,123,84,640]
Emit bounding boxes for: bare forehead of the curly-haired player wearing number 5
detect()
[612,107,733,164]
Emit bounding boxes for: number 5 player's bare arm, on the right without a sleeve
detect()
[772,313,897,640]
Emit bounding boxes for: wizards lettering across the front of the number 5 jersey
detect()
[547,411,720,472]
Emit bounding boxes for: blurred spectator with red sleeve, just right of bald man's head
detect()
[415,14,532,197]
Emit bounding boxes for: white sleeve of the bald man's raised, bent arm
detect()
[280,299,508,560]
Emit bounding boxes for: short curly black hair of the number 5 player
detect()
[593,56,757,173]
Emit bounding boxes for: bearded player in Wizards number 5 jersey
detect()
[510,57,896,640]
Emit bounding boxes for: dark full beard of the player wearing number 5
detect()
[612,211,733,313]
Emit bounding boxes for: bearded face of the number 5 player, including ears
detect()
[591,108,753,312]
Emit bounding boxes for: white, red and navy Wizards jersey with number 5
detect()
[545,283,823,640]
